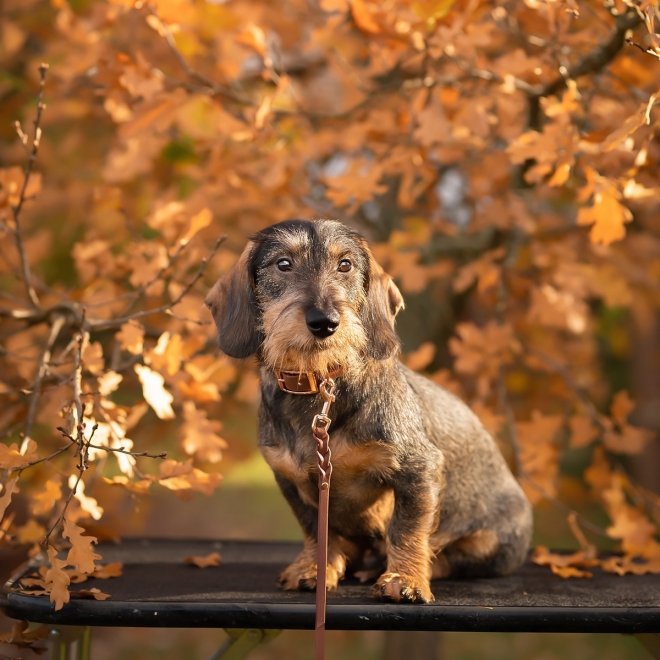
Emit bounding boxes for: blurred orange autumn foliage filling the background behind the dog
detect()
[0,0,660,658]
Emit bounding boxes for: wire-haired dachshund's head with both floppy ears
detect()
[206,220,403,375]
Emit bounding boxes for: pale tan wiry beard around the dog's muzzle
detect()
[261,299,367,377]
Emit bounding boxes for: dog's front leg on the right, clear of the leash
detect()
[374,463,441,603]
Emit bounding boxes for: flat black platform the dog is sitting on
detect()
[0,539,660,633]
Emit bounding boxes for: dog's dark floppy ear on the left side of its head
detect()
[204,241,263,358]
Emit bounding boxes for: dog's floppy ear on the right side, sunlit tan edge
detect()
[362,245,404,360]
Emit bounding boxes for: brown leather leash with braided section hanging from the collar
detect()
[312,378,335,660]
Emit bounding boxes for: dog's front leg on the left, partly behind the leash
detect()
[275,474,346,591]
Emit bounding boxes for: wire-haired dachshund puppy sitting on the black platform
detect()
[206,220,532,603]
